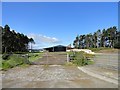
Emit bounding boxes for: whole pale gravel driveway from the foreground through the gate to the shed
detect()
[2,53,117,88]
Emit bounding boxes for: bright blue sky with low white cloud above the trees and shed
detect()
[2,2,118,49]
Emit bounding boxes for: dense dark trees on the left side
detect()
[0,25,34,53]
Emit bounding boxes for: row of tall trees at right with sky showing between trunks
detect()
[73,26,120,49]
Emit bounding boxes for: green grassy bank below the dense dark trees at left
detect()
[1,53,42,70]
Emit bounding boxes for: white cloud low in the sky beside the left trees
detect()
[27,34,61,48]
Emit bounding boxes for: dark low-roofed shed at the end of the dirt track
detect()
[44,45,67,52]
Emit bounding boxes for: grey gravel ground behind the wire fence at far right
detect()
[94,53,119,71]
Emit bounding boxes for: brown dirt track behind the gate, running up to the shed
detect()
[34,52,67,65]
